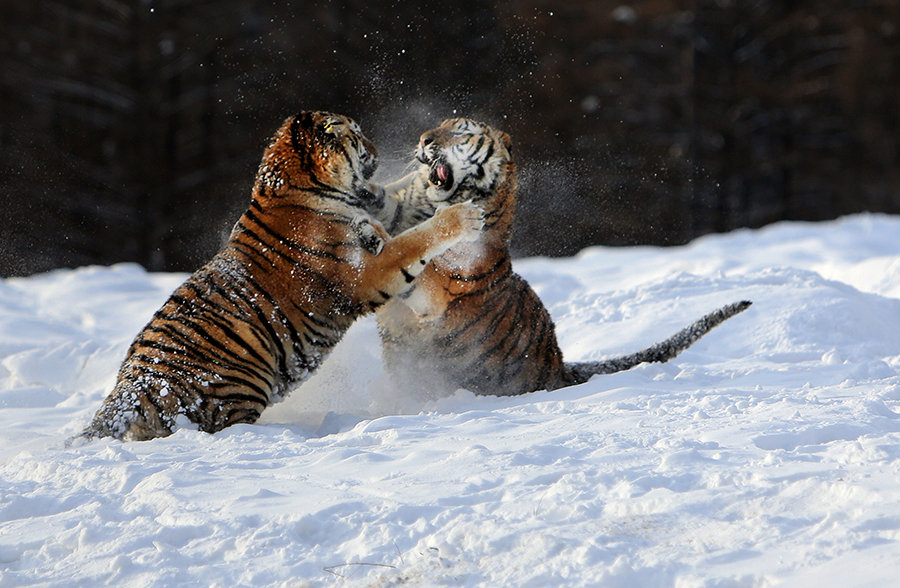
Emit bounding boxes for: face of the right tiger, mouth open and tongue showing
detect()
[416,118,512,202]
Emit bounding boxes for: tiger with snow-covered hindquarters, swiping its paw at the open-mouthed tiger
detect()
[81,111,484,441]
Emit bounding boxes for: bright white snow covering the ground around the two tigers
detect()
[0,215,900,588]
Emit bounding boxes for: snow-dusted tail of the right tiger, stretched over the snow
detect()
[563,300,753,386]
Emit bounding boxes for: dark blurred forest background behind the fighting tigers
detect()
[0,0,900,276]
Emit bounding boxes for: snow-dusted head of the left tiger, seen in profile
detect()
[255,111,378,206]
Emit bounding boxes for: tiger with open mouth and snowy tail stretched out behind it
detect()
[370,118,751,396]
